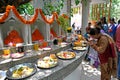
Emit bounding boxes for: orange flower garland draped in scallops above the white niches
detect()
[0,5,68,24]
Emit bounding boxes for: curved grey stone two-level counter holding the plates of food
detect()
[0,44,86,80]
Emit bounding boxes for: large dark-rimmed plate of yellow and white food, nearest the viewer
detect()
[6,63,37,80]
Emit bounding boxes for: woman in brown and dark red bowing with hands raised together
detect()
[89,27,117,80]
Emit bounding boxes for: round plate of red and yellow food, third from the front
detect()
[56,51,76,60]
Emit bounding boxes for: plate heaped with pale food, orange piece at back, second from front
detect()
[37,54,58,69]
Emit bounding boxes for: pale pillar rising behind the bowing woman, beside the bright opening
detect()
[81,0,90,34]
